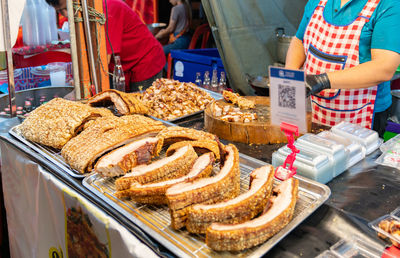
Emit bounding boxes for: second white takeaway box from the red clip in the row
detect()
[296,134,347,177]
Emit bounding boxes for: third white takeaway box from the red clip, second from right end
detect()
[318,131,365,169]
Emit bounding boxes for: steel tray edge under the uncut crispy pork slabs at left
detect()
[9,125,88,179]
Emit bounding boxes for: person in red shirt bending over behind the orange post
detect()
[46,0,166,92]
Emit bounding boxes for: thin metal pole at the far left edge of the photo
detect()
[1,0,17,117]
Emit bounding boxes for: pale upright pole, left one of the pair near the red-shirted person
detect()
[67,1,82,100]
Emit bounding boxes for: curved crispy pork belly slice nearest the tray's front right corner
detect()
[206,178,299,251]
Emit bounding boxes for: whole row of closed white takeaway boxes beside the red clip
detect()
[272,122,382,184]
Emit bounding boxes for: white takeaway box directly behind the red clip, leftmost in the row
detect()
[272,144,333,184]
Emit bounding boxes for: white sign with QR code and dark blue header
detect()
[269,66,307,133]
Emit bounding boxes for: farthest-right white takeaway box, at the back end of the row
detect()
[331,121,383,155]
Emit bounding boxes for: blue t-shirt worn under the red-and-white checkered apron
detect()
[296,0,400,112]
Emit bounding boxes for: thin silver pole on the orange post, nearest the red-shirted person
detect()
[81,0,101,94]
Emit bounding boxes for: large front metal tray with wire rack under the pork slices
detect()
[83,154,330,257]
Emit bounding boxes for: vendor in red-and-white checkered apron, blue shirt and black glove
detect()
[286,0,400,136]
